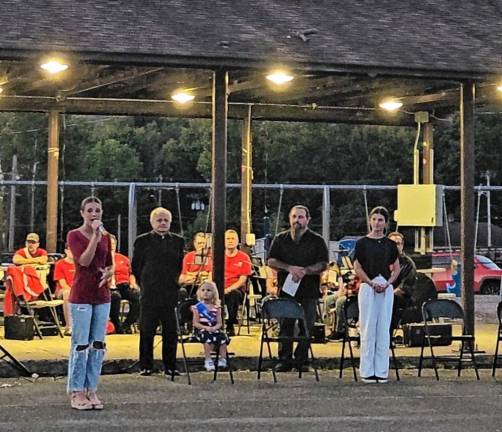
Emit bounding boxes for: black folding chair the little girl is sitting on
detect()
[171,299,234,385]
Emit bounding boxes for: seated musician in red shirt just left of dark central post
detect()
[179,232,213,297]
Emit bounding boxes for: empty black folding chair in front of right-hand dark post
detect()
[418,299,479,381]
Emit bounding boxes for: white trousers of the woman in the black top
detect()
[358,276,394,378]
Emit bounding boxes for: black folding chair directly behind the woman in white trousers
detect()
[339,296,401,381]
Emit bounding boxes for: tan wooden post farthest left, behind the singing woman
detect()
[45,111,59,252]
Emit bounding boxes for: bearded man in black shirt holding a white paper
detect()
[268,205,329,372]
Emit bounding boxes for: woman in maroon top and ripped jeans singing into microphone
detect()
[67,197,113,410]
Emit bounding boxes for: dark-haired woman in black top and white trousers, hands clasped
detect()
[354,207,400,383]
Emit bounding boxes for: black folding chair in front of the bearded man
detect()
[258,298,319,383]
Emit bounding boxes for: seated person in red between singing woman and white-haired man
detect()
[110,235,140,334]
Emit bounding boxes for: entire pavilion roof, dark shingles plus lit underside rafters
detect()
[0,0,502,122]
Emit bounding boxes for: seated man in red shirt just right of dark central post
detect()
[224,230,253,336]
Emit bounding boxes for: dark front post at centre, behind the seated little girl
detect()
[211,69,228,302]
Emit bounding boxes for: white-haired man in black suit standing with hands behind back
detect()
[132,207,184,376]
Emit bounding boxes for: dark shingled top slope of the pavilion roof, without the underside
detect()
[0,0,502,74]
